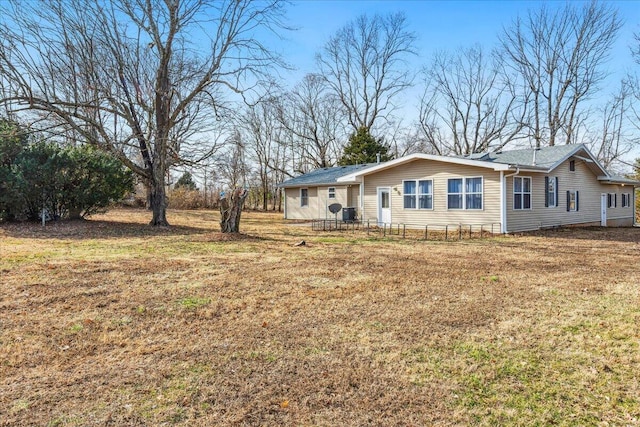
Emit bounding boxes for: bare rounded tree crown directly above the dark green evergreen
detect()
[316,13,416,132]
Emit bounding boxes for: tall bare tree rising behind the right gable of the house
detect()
[501,0,621,147]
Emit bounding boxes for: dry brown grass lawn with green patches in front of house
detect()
[0,210,640,426]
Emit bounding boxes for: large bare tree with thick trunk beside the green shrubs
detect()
[0,0,283,229]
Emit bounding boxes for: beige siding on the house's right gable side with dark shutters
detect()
[506,159,633,232]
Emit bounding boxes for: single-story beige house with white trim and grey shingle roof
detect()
[280,144,640,233]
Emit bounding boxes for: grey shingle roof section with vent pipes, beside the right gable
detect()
[468,144,584,169]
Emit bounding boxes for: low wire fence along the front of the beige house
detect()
[311,219,502,241]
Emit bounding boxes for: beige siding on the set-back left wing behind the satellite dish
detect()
[285,185,359,219]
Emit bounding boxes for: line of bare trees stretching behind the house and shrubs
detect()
[0,0,640,231]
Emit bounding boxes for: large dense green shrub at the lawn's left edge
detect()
[0,130,133,220]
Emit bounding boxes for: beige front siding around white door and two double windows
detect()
[362,160,500,226]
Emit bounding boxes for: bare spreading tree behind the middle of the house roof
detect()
[419,45,526,155]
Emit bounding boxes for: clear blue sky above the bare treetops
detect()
[283,0,640,83]
